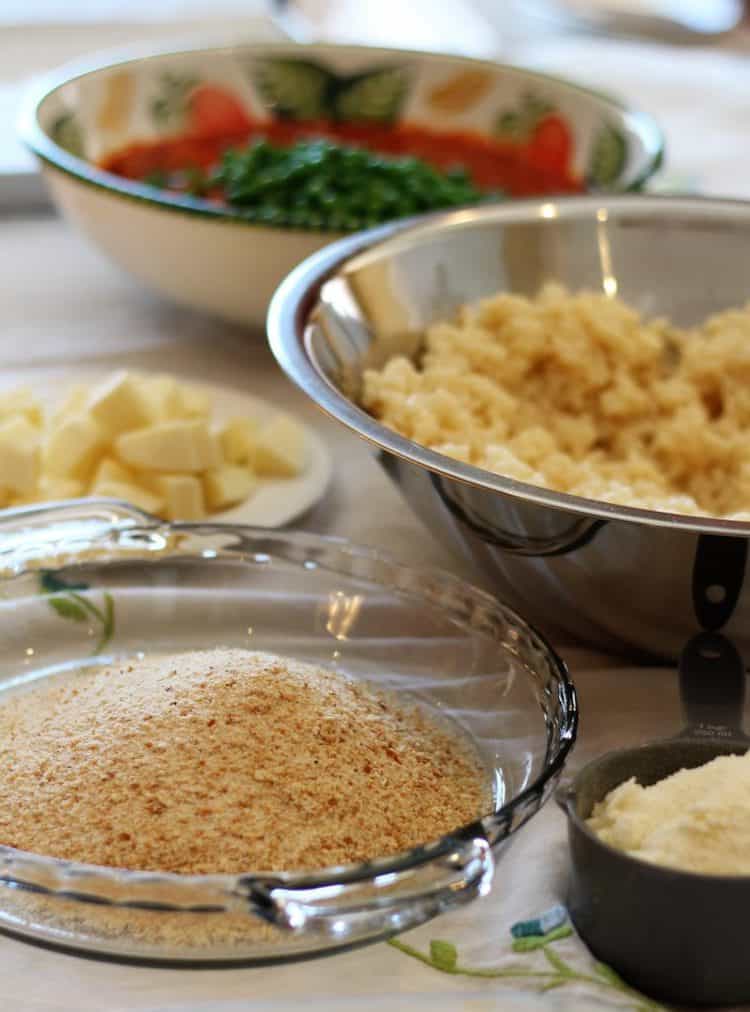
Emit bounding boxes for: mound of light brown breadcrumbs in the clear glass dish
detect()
[0,649,487,874]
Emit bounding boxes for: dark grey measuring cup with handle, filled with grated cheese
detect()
[557,535,750,1004]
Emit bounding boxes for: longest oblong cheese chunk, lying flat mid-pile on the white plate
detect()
[114,419,217,474]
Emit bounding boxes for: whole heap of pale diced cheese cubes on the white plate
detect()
[0,370,307,521]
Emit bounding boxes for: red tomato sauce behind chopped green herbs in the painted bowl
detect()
[101,116,584,196]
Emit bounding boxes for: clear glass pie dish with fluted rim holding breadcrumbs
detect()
[0,500,577,964]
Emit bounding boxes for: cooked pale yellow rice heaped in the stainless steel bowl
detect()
[362,284,750,520]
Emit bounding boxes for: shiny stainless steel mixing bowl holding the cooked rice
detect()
[268,196,750,659]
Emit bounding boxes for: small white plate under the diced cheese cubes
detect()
[1,368,333,527]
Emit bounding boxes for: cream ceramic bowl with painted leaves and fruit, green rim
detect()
[21,44,663,325]
